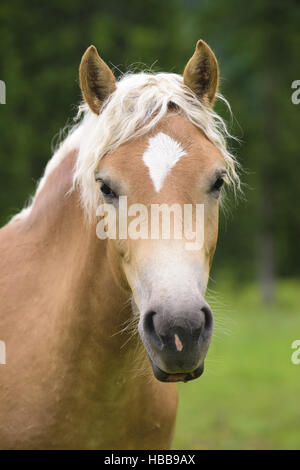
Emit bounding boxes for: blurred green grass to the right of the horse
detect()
[173,281,300,449]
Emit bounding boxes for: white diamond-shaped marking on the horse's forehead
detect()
[143,132,186,192]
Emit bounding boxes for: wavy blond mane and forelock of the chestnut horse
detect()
[15,73,240,222]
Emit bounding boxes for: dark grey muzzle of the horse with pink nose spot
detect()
[139,302,213,382]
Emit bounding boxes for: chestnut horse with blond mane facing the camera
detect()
[0,40,239,449]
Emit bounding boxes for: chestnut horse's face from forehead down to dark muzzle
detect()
[96,113,226,381]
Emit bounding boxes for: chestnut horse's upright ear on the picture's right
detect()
[183,40,219,106]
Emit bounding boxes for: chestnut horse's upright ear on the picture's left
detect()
[79,46,116,114]
